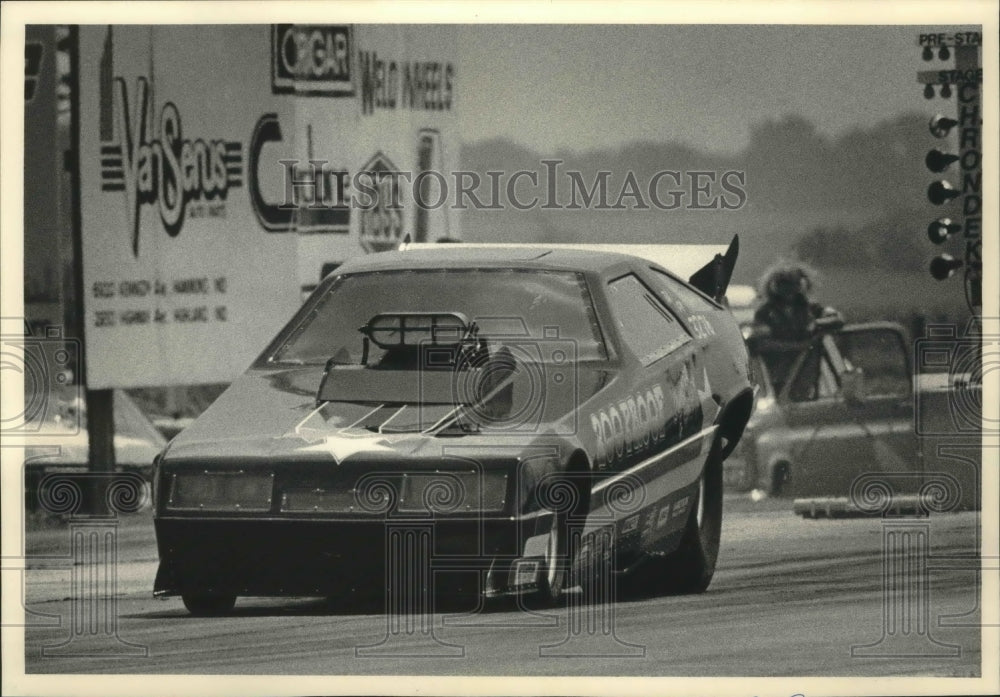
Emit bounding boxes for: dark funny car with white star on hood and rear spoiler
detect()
[154,239,753,614]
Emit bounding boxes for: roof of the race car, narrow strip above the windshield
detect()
[334,244,648,275]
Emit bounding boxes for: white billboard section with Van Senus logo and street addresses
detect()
[80,26,298,389]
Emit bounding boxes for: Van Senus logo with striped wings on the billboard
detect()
[101,78,243,257]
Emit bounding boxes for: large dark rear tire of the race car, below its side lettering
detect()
[663,442,722,593]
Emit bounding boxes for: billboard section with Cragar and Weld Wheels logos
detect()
[274,24,460,288]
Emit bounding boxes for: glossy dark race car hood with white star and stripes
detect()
[166,365,613,462]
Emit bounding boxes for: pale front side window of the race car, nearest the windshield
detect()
[608,274,691,365]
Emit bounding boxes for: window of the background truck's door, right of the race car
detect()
[836,329,912,397]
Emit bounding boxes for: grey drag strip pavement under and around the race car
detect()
[25,506,981,676]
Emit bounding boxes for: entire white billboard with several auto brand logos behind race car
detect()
[80,25,457,389]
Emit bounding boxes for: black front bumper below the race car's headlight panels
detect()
[154,514,552,596]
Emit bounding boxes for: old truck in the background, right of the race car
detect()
[725,322,979,510]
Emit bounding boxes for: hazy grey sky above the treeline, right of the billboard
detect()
[460,25,980,152]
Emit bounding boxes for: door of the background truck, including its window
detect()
[782,325,919,496]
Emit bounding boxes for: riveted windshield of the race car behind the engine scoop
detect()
[268,268,607,364]
